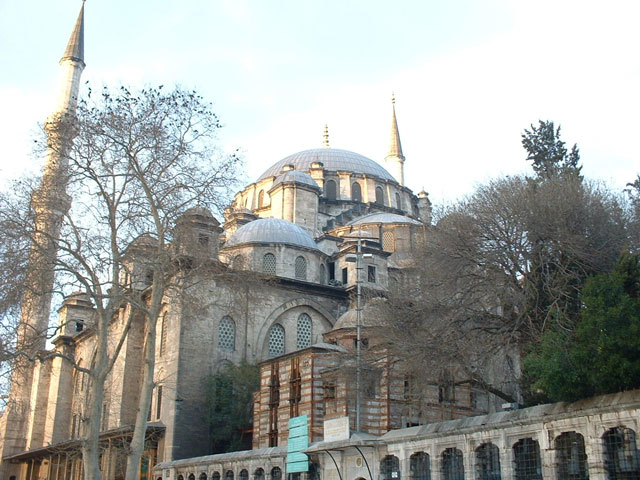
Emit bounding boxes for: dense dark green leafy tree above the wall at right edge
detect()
[525,254,640,401]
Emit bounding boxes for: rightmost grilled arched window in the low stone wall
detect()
[602,427,640,480]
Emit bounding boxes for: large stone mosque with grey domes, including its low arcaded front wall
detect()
[0,3,640,480]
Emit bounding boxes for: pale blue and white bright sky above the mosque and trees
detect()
[0,0,640,204]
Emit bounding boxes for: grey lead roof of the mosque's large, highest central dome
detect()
[258,148,396,182]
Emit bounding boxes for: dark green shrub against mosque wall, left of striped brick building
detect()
[205,362,260,453]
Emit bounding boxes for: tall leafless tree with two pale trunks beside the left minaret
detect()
[0,87,239,480]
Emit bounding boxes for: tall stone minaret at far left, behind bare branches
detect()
[0,2,85,464]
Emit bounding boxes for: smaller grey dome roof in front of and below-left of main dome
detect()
[225,218,318,250]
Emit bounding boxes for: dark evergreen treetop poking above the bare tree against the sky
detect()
[522,120,582,180]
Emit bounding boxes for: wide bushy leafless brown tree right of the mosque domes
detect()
[380,175,626,401]
